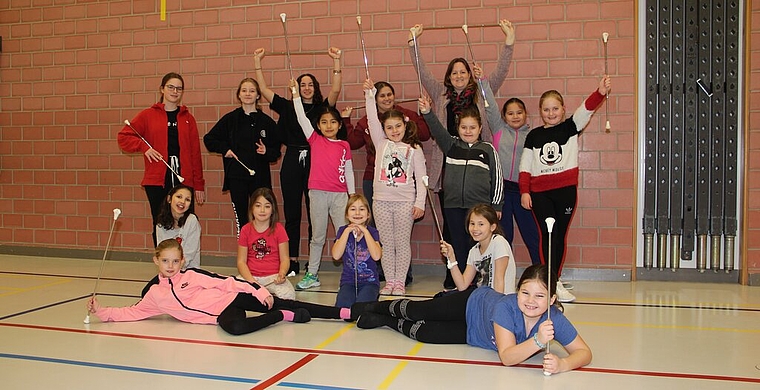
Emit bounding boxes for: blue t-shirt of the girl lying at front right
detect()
[467,286,578,351]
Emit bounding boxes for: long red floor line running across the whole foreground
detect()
[0,322,760,383]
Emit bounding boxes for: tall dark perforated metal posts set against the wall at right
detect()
[637,0,742,282]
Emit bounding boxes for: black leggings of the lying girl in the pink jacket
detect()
[217,293,340,335]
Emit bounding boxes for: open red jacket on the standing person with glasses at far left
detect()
[117,103,206,191]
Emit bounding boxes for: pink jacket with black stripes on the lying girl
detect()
[95,268,271,324]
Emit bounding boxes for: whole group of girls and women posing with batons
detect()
[108,20,610,372]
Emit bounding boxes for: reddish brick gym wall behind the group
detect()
[0,0,748,278]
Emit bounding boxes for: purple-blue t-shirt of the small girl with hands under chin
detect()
[336,225,380,286]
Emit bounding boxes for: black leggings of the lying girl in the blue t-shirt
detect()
[365,288,475,344]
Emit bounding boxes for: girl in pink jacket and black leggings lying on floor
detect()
[87,239,351,335]
